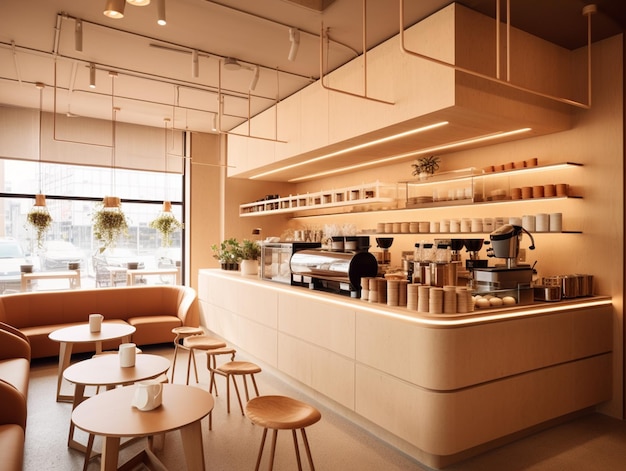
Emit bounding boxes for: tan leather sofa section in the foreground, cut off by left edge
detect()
[0,323,30,471]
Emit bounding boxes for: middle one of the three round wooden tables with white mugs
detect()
[63,353,170,454]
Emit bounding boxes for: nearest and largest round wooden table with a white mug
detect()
[72,384,214,471]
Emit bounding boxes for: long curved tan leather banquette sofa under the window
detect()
[0,285,199,358]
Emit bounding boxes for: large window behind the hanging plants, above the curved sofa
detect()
[0,160,183,292]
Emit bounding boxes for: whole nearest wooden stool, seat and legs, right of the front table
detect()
[246,396,322,471]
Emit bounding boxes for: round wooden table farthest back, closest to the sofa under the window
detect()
[48,322,137,402]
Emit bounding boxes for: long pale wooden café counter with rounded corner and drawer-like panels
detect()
[198,270,612,468]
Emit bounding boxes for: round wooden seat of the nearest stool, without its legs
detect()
[246,396,322,430]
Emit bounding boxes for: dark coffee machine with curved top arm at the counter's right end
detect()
[473,224,535,304]
